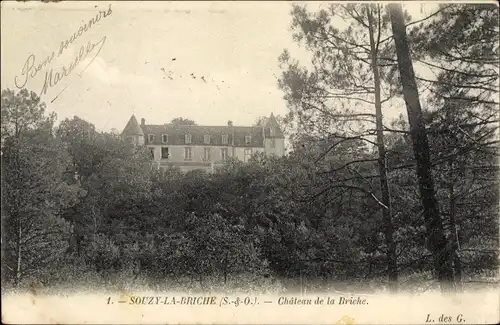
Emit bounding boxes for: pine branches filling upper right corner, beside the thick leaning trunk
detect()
[409,4,499,110]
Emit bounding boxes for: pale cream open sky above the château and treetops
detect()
[1,1,442,132]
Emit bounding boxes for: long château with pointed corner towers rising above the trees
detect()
[121,113,285,171]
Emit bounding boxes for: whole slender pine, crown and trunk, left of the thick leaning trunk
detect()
[280,4,404,291]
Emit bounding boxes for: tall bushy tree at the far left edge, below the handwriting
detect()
[2,89,81,285]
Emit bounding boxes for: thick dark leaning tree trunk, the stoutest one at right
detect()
[389,4,454,292]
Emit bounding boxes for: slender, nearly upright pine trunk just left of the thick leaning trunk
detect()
[366,5,398,292]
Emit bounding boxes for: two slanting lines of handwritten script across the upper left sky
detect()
[14,5,113,102]
